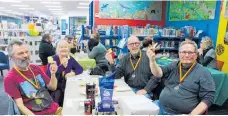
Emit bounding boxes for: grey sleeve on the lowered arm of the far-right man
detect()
[199,72,215,107]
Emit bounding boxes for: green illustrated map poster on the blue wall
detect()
[169,0,216,21]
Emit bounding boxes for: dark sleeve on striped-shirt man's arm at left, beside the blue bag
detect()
[110,57,125,79]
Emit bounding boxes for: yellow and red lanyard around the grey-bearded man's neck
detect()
[14,66,39,89]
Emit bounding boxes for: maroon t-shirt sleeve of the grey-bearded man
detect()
[4,77,21,99]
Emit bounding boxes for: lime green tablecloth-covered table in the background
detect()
[71,55,96,70]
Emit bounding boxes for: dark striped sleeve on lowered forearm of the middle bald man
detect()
[144,76,160,93]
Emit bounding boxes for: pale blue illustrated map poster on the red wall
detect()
[99,0,162,20]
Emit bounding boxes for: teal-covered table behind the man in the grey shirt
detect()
[156,58,228,106]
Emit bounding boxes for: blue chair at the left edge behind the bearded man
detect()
[0,51,9,76]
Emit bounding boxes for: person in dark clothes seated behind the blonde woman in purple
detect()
[39,34,55,65]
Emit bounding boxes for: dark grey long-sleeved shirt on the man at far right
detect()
[160,62,215,114]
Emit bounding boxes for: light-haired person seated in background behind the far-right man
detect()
[198,36,217,69]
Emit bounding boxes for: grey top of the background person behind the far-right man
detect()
[204,49,217,69]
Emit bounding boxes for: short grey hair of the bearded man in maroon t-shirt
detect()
[7,39,25,57]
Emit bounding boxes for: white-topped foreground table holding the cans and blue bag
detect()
[62,71,159,115]
